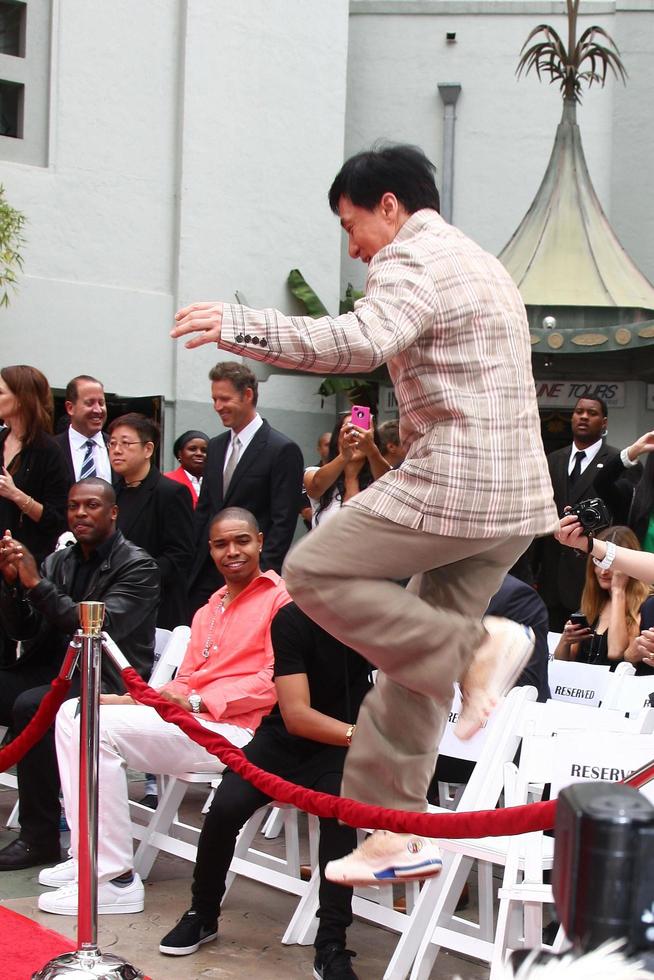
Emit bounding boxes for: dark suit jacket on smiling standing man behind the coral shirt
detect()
[191,419,304,593]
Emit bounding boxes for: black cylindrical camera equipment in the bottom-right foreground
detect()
[552,783,654,953]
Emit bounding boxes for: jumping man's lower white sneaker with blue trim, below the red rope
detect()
[325,830,443,885]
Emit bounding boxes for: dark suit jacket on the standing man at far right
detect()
[536,443,620,616]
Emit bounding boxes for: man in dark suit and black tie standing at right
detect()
[535,398,620,632]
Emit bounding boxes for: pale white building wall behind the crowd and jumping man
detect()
[0,0,654,458]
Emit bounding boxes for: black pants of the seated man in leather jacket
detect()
[0,670,79,851]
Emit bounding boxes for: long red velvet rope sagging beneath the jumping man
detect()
[122,667,556,838]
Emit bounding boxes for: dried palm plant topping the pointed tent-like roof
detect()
[516,0,627,102]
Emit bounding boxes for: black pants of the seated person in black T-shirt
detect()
[192,723,356,949]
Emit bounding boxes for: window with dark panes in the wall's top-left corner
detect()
[0,0,52,167]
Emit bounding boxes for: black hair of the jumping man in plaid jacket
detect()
[329,143,440,214]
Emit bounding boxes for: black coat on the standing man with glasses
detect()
[114,466,193,629]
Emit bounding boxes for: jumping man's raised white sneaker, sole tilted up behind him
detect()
[454,616,534,739]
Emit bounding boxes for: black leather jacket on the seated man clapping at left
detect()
[0,531,160,693]
